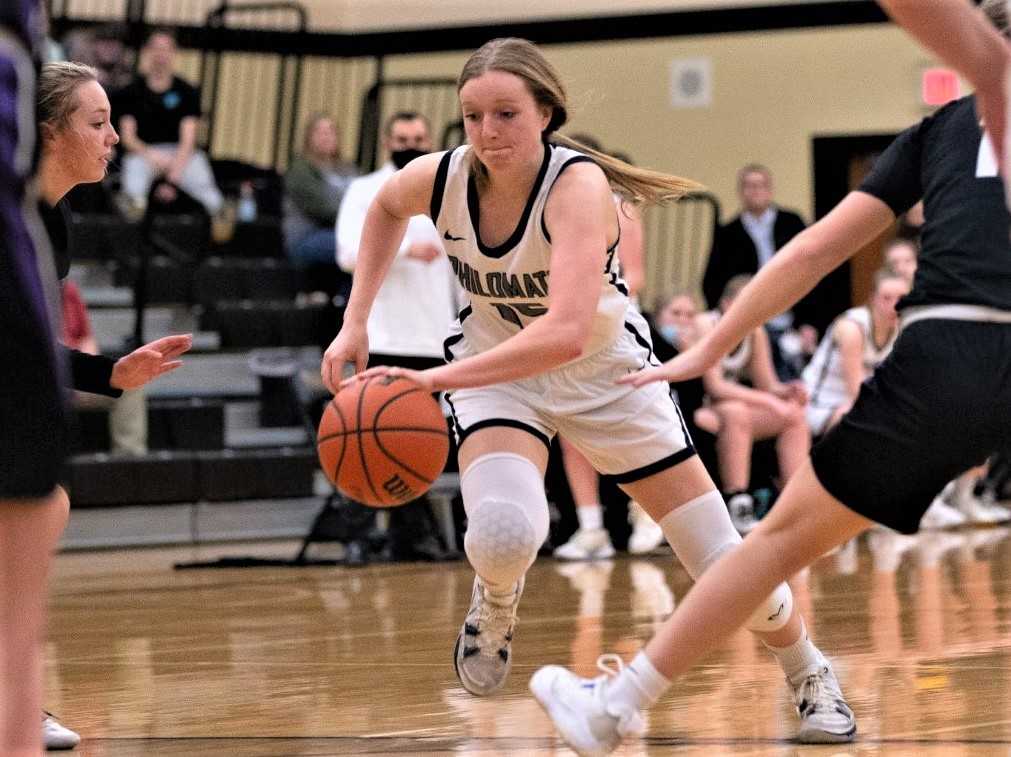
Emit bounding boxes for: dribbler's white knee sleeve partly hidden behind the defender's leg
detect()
[660,489,794,632]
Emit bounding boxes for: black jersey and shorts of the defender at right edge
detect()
[812,97,1011,533]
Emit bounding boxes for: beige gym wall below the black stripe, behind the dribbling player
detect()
[378,24,929,224]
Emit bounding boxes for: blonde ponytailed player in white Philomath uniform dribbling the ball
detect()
[321,39,854,741]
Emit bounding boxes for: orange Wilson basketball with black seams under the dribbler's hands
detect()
[316,376,449,507]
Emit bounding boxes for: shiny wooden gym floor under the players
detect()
[47,529,1011,757]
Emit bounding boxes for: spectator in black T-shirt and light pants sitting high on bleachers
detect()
[115,29,223,216]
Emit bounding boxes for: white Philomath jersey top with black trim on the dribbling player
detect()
[431,145,629,360]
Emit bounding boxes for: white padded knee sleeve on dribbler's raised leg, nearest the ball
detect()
[460,453,549,592]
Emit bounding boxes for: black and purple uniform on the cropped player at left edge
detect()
[0,10,66,499]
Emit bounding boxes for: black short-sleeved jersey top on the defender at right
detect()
[859,97,1011,310]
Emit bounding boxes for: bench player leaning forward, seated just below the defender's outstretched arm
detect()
[696,275,811,534]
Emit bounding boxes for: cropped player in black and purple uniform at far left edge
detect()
[0,0,71,757]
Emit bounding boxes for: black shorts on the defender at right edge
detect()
[811,319,1011,534]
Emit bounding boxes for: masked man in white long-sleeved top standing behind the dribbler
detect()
[337,111,457,560]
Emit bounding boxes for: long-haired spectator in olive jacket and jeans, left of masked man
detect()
[283,113,361,295]
